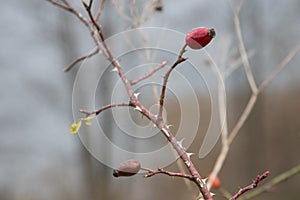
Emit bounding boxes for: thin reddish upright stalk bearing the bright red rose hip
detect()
[157,44,187,120]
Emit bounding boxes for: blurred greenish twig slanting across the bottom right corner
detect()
[240,165,300,200]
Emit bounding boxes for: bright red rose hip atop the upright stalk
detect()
[185,27,216,49]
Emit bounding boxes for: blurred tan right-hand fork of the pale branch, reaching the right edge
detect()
[258,44,300,92]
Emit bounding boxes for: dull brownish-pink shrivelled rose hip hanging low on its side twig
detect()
[113,160,141,177]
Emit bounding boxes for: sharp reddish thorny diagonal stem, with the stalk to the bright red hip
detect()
[48,0,212,200]
